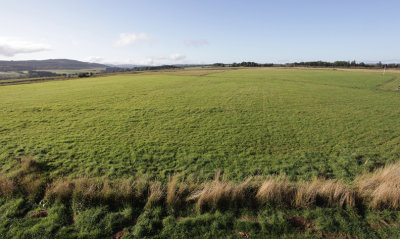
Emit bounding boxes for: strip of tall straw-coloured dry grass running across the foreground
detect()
[0,159,400,211]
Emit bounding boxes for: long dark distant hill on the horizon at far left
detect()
[0,59,107,72]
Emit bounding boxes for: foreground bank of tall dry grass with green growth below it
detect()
[0,159,400,238]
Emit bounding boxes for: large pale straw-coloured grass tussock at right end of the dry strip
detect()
[356,163,400,209]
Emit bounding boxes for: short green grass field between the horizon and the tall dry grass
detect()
[0,69,400,180]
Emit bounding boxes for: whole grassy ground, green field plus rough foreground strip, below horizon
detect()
[0,68,400,238]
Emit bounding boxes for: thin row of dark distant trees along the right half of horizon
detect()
[212,61,399,68]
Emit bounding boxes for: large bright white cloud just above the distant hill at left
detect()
[0,37,51,57]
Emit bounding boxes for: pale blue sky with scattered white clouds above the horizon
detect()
[0,0,400,65]
